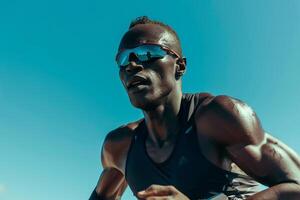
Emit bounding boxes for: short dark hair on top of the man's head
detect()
[128,16,180,44]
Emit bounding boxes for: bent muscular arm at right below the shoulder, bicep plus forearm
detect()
[227,131,300,200]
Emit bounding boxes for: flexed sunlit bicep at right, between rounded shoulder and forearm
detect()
[226,134,300,186]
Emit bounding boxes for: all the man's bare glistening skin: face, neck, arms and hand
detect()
[90,24,300,200]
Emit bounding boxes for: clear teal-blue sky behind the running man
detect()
[0,0,300,200]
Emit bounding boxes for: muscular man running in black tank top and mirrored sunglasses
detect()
[90,17,300,200]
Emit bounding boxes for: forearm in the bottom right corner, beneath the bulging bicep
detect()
[247,183,300,200]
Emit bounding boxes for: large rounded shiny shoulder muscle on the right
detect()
[195,95,264,145]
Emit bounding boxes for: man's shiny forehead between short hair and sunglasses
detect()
[119,24,176,50]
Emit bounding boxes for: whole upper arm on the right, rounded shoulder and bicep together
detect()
[195,96,300,185]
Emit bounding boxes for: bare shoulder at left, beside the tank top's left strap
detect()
[101,120,142,173]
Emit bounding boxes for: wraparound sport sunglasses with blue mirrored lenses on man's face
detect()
[116,44,181,69]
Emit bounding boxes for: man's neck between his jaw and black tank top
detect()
[143,90,182,147]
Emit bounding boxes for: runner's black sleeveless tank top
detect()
[125,93,258,200]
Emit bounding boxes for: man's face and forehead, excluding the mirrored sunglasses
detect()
[119,24,183,110]
